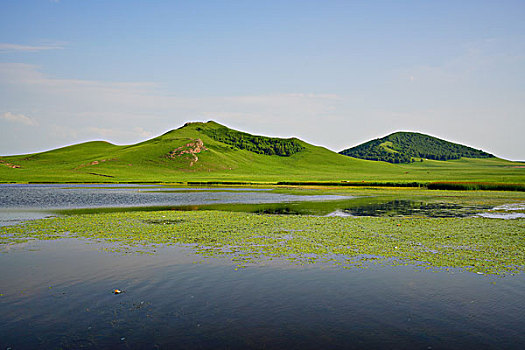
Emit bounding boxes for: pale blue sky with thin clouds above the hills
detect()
[0,0,525,160]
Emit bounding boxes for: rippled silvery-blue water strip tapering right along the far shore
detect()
[0,184,346,209]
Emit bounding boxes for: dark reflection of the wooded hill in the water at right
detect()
[343,200,490,218]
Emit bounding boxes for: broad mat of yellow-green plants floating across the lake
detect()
[0,211,525,274]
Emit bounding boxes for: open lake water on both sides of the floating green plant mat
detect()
[0,185,525,349]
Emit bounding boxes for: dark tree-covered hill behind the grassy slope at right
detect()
[339,131,494,163]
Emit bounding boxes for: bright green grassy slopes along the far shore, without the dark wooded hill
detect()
[0,122,525,183]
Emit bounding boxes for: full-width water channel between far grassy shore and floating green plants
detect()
[0,184,525,221]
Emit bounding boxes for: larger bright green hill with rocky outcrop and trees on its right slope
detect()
[0,121,385,182]
